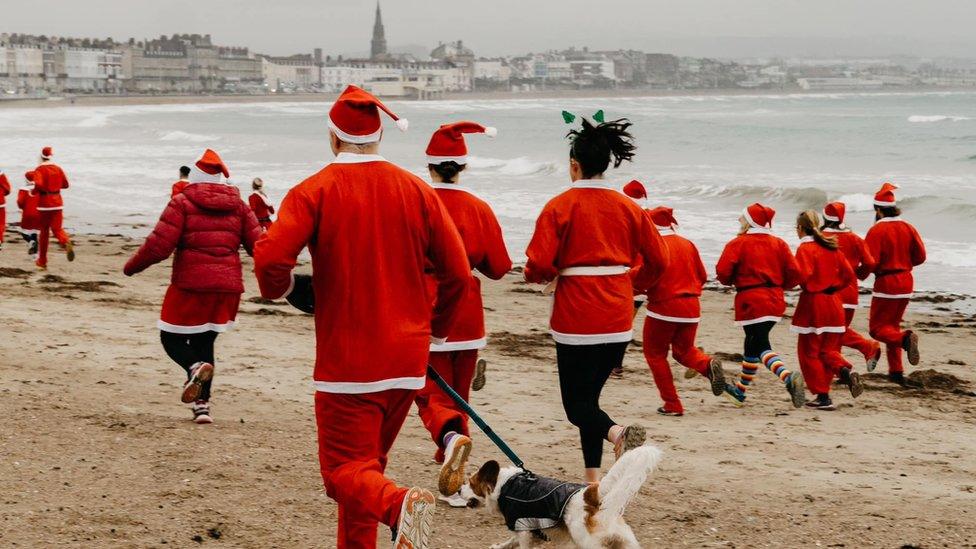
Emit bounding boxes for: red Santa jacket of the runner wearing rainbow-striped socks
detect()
[715,228,799,326]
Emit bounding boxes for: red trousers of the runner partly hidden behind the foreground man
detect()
[417,349,478,463]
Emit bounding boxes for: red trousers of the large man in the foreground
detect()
[315,389,417,549]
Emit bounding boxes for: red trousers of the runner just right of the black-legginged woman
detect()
[644,316,712,413]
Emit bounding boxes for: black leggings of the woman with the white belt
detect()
[556,342,630,468]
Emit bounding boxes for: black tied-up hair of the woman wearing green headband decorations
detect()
[566,118,637,178]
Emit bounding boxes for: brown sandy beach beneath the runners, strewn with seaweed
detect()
[0,233,976,548]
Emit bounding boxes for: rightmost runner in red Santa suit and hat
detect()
[864,182,925,385]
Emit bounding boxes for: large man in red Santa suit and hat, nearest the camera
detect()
[254,86,472,548]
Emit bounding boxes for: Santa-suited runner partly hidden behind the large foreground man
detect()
[416,122,512,507]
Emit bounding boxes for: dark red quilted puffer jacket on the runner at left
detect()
[124,183,261,293]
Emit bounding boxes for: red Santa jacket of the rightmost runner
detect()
[864,217,925,299]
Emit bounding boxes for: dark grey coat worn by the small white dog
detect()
[498,473,587,532]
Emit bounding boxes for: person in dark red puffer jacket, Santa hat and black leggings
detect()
[123,149,261,424]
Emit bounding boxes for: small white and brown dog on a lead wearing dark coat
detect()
[461,446,661,549]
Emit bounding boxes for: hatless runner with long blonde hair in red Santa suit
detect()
[790,210,864,410]
